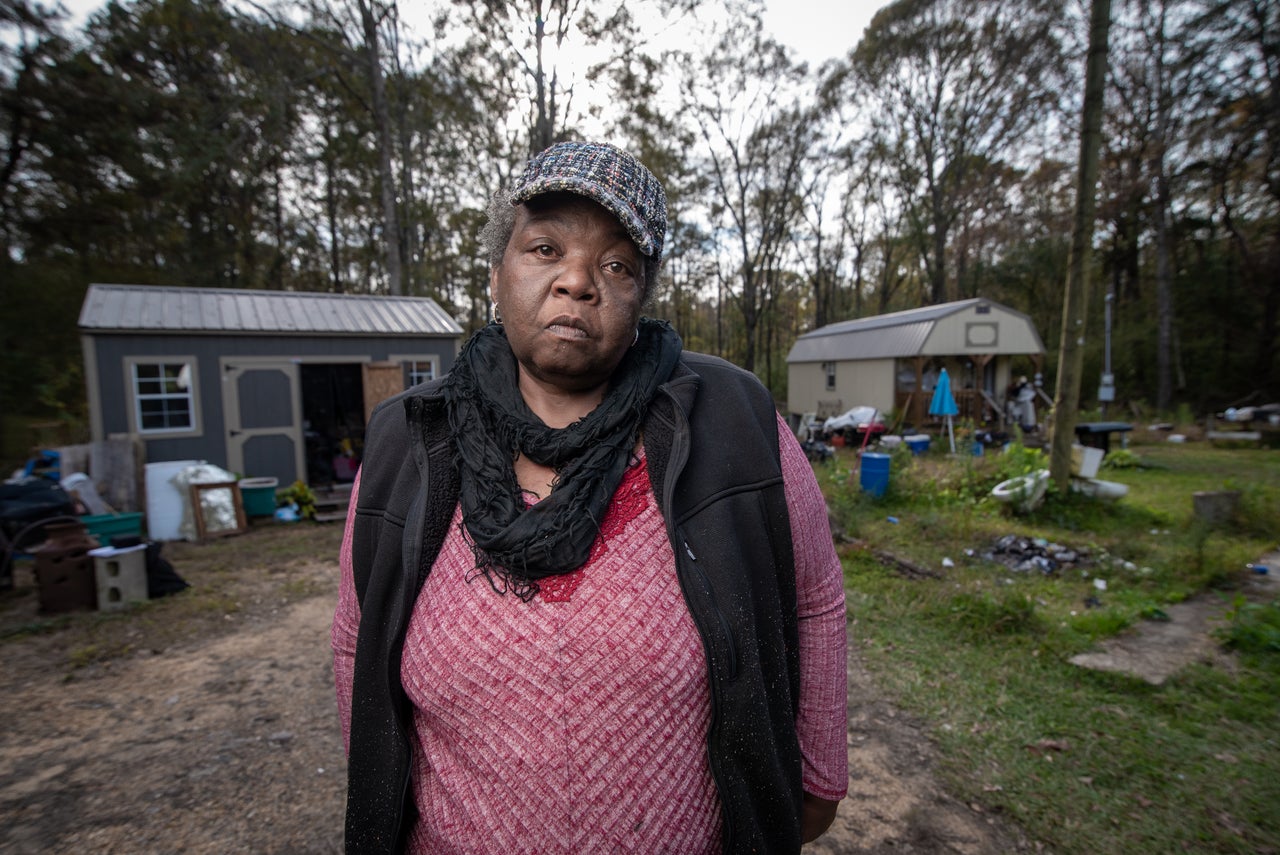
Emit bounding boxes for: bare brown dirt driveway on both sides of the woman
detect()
[0,526,1032,855]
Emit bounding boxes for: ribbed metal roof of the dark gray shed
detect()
[79,284,462,338]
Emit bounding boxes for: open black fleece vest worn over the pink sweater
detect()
[346,353,801,854]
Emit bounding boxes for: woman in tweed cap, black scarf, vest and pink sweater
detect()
[332,143,847,854]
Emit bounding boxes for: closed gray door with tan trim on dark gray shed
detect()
[221,358,306,488]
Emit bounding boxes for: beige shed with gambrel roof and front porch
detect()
[787,297,1044,428]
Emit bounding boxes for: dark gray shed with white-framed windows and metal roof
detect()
[79,284,462,486]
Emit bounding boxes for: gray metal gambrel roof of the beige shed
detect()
[787,297,1044,362]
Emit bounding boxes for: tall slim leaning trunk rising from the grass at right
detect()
[1050,0,1111,490]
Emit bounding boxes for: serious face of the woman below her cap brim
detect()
[489,193,644,393]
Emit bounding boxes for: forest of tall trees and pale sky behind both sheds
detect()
[0,0,1280,460]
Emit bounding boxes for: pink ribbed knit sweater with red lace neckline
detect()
[332,412,847,855]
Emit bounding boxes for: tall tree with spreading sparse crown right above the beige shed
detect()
[847,0,1064,303]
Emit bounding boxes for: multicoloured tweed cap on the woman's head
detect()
[511,142,667,262]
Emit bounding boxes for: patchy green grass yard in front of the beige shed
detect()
[818,444,1280,854]
